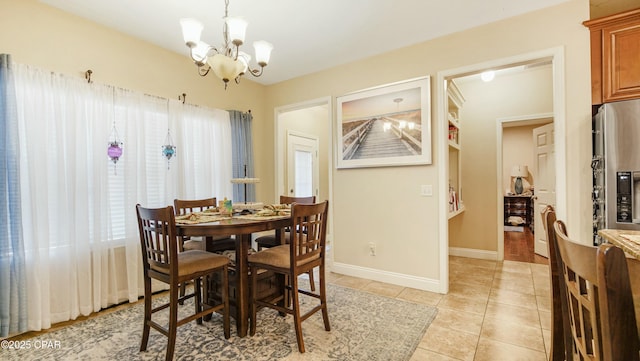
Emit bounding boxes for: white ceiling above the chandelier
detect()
[40,0,568,84]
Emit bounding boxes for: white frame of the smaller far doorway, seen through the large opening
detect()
[496,113,558,261]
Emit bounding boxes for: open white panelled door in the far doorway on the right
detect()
[533,123,556,257]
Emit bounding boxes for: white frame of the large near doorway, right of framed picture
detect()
[436,46,567,293]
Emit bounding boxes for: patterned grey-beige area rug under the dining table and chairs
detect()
[5,285,437,361]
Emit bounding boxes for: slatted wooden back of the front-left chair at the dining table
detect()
[136,205,178,284]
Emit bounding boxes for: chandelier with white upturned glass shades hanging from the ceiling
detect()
[180,0,273,89]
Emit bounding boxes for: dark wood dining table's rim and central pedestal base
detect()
[176,212,291,337]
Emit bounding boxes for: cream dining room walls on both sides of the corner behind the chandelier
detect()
[0,0,591,287]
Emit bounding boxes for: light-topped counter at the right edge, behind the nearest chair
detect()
[598,229,640,334]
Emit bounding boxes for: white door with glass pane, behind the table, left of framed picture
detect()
[286,131,320,198]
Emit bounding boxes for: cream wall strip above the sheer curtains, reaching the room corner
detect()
[0,0,274,197]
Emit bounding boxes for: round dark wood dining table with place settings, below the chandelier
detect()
[176,210,291,337]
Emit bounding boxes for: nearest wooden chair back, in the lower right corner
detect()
[554,221,640,361]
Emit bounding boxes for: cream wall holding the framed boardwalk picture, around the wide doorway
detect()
[267,0,590,281]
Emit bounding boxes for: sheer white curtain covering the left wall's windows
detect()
[13,65,231,330]
